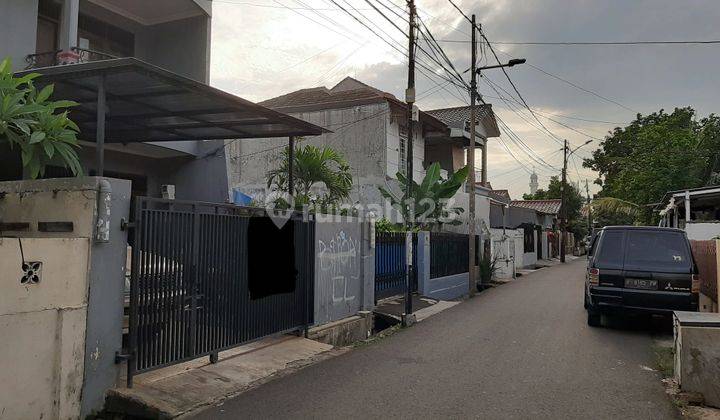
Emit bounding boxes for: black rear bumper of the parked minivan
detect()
[589,287,698,314]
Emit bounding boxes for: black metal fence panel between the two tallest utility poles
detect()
[430,232,470,279]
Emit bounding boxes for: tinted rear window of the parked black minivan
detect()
[625,231,691,271]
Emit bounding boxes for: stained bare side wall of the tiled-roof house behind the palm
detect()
[226,103,390,208]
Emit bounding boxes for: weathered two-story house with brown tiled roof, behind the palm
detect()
[226,77,449,210]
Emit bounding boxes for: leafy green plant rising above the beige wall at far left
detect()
[0,59,82,179]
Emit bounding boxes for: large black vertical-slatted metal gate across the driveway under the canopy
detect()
[127,197,315,386]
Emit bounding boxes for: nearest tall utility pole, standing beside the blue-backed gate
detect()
[402,0,416,326]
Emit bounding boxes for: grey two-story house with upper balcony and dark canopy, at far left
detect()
[0,0,322,202]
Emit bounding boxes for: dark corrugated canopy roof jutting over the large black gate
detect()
[19,58,328,143]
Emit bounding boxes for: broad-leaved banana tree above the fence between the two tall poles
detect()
[378,162,470,230]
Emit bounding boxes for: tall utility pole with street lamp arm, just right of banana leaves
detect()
[468,15,478,296]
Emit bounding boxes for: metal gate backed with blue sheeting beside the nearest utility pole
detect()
[375,232,418,300]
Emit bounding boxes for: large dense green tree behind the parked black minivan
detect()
[583,107,720,223]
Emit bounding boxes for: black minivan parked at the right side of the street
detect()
[585,226,700,326]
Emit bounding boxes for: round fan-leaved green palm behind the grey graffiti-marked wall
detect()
[267,145,352,210]
